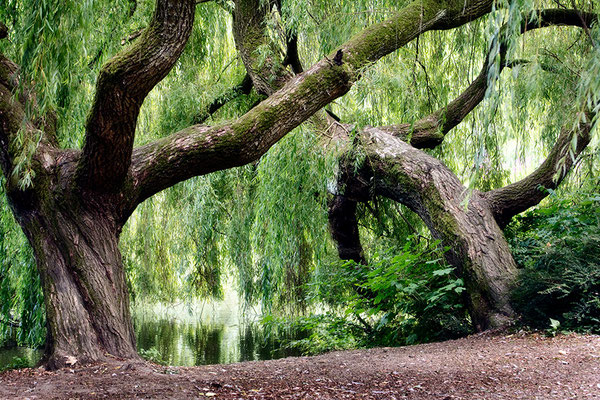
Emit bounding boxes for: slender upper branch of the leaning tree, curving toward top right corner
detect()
[379,9,597,148]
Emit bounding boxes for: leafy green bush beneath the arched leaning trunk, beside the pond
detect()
[268,241,471,353]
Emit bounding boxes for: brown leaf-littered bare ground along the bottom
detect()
[0,333,600,400]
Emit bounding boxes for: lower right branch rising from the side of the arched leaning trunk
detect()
[484,117,591,227]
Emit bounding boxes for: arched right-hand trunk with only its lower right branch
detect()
[329,115,590,331]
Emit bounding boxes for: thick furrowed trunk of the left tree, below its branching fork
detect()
[11,181,138,368]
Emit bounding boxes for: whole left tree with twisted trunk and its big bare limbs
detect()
[0,0,596,368]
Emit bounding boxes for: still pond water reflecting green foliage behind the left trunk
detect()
[0,294,300,370]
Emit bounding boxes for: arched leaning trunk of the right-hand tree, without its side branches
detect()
[330,128,517,331]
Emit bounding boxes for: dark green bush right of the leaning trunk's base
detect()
[507,194,600,333]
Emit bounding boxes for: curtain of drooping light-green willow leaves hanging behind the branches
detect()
[0,0,600,344]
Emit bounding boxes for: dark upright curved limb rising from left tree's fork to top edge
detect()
[78,0,195,190]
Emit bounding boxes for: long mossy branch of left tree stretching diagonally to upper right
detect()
[125,0,500,216]
